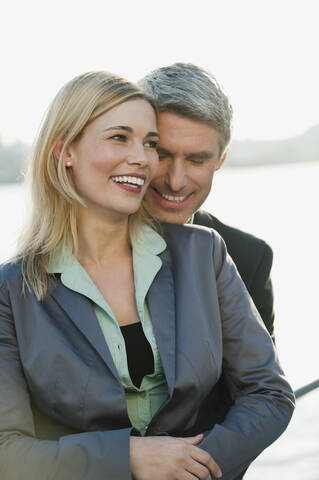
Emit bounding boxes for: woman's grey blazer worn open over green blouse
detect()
[0,225,294,480]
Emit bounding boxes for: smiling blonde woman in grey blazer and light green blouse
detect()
[0,72,293,480]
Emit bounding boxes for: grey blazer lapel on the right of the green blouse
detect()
[147,250,176,396]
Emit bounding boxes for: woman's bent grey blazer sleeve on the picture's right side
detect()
[201,235,294,480]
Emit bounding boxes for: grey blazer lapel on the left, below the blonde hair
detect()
[51,281,120,382]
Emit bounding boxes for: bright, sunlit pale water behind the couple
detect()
[0,163,319,480]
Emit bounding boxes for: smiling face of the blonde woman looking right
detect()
[66,99,158,223]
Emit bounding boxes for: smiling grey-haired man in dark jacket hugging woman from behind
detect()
[140,63,274,479]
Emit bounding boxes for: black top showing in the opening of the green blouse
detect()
[120,322,154,388]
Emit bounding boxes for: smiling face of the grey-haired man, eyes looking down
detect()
[145,112,226,223]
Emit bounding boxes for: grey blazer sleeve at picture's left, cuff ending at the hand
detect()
[0,282,132,480]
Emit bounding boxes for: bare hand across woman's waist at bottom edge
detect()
[130,434,222,480]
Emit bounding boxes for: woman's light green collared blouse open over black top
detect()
[48,226,168,435]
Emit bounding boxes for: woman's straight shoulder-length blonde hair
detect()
[14,71,156,300]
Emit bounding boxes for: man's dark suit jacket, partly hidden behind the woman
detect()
[194,210,274,480]
